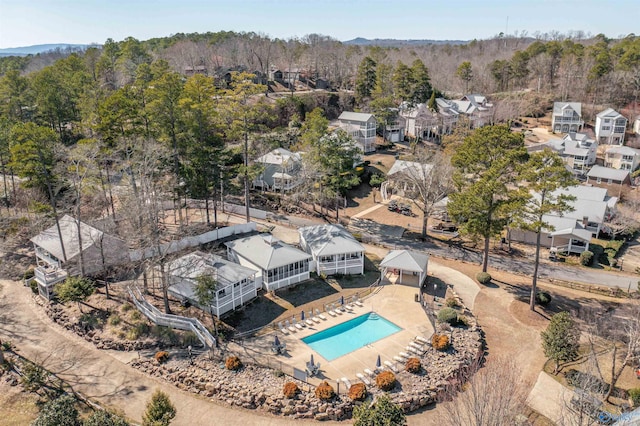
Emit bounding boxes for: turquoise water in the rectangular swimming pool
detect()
[302,312,402,361]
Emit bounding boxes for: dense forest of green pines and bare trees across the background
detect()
[0,32,640,253]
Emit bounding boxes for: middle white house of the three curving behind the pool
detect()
[225,234,311,291]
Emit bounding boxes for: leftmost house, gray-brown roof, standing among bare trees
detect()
[31,215,129,298]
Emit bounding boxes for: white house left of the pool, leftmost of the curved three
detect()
[166,251,257,317]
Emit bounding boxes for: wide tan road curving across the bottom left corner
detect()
[0,280,320,426]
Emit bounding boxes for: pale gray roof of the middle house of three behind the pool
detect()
[225,234,311,270]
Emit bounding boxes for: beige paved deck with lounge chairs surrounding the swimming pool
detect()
[236,284,433,385]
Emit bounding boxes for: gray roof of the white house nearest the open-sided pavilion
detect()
[298,224,364,257]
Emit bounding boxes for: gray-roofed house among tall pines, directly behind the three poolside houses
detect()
[253,148,302,192]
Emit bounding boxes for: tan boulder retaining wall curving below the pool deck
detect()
[131,326,484,420]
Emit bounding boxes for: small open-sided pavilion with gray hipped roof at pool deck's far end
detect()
[380,250,429,287]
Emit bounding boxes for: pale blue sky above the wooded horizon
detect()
[0,0,640,48]
